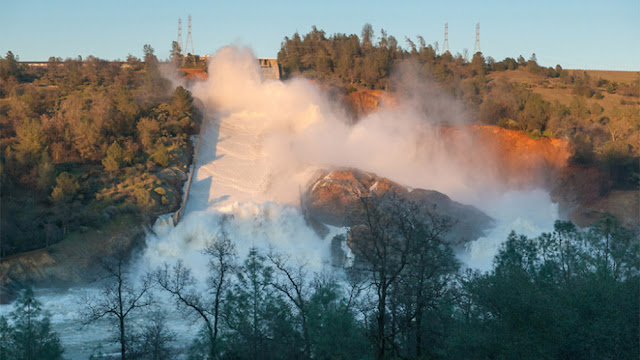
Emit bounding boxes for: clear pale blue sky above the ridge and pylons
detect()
[0,0,640,71]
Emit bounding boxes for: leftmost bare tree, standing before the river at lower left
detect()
[83,251,153,360]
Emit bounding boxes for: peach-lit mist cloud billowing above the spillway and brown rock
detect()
[193,47,495,204]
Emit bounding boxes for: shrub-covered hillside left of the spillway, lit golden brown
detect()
[0,45,198,257]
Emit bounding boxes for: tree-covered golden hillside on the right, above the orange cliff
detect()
[278,24,640,188]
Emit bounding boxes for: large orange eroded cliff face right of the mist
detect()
[444,125,640,229]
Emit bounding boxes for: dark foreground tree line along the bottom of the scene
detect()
[0,197,640,359]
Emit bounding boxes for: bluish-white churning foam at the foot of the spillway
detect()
[142,202,344,278]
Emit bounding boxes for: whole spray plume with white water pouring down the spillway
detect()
[149,47,555,270]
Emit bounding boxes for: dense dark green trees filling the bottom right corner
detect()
[452,217,640,359]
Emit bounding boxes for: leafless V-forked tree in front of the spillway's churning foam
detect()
[155,231,237,358]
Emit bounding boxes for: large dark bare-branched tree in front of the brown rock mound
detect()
[349,194,457,359]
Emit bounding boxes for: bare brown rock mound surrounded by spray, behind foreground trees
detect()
[302,169,492,245]
